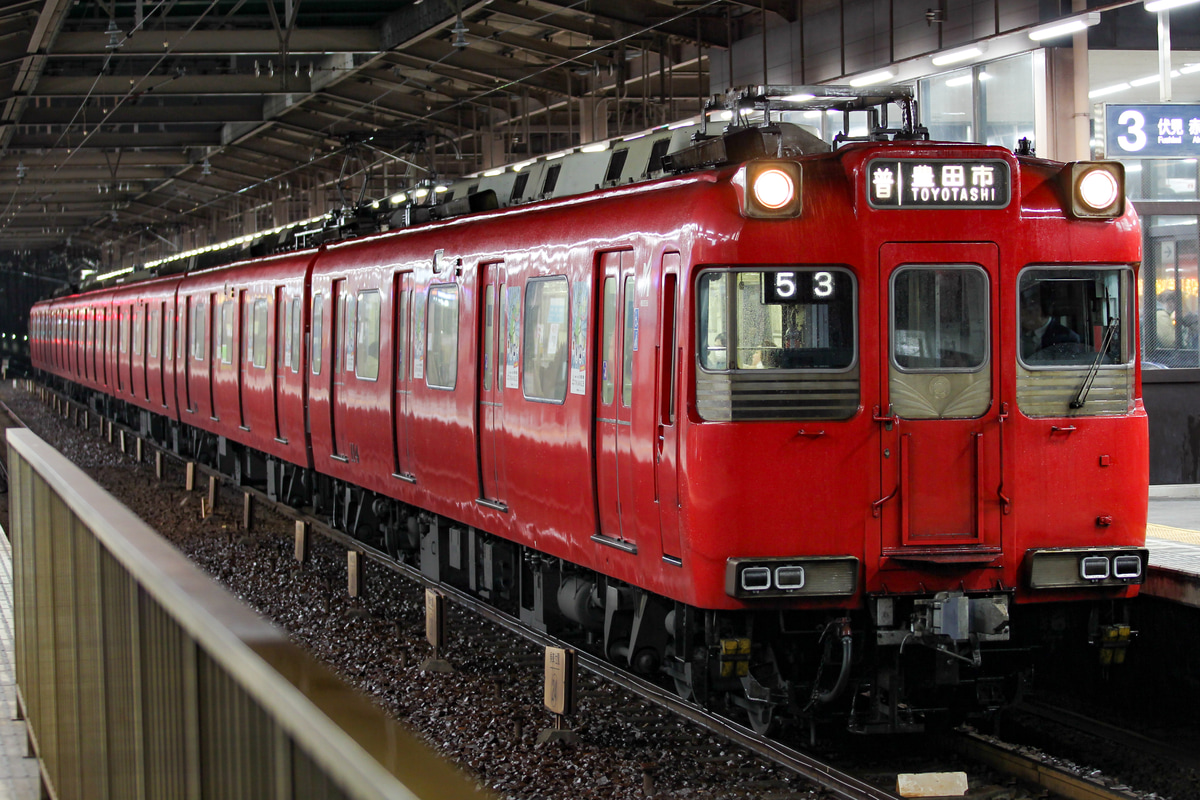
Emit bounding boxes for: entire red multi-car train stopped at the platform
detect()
[31,86,1147,730]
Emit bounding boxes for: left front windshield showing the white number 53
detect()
[697,267,856,372]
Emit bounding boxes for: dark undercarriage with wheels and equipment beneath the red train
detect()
[68,386,1130,735]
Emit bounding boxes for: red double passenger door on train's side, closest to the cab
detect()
[594,251,637,552]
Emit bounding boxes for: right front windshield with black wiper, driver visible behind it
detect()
[1018,267,1133,369]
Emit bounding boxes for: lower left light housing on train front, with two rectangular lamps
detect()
[725,555,858,600]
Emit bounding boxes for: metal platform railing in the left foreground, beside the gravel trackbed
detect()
[7,428,484,800]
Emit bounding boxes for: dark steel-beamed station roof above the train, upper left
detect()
[0,0,768,252]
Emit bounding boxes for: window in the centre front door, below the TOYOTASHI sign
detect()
[892,266,989,372]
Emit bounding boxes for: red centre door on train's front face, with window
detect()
[875,243,1003,569]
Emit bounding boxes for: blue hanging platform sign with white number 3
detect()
[1104,103,1200,158]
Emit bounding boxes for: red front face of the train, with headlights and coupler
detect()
[685,90,1148,730]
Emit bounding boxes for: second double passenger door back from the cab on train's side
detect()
[476,261,508,509]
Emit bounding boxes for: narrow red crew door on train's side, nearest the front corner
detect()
[654,253,683,560]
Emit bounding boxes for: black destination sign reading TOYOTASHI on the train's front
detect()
[866,158,1013,209]
